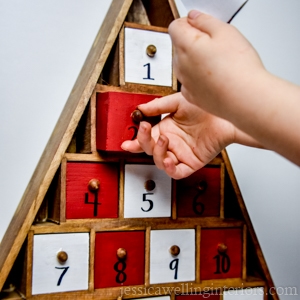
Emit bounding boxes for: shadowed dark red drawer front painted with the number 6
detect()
[176,167,221,217]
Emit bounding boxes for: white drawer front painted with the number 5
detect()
[124,164,172,218]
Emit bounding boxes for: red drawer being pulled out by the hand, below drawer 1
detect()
[96,92,160,151]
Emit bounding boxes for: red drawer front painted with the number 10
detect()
[200,228,243,280]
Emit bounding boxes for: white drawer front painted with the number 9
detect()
[150,229,195,284]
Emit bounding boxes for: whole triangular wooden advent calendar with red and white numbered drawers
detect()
[0,0,278,300]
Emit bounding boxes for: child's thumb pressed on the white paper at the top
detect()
[187,10,226,35]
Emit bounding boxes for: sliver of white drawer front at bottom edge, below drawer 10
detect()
[223,287,265,300]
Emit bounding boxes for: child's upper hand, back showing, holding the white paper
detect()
[169,11,265,120]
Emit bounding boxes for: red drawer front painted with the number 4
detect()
[66,162,119,219]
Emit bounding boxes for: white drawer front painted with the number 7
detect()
[32,233,89,295]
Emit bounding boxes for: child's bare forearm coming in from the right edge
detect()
[223,71,300,165]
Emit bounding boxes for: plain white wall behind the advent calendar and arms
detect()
[0,0,300,299]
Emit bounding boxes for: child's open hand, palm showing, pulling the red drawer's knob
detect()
[122,93,257,179]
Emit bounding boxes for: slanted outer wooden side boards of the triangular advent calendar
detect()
[0,0,278,299]
